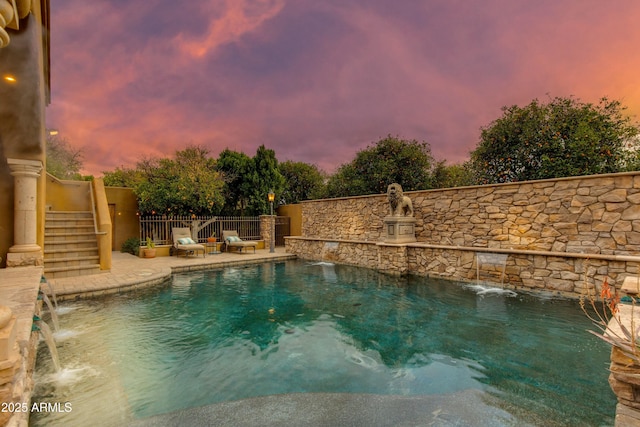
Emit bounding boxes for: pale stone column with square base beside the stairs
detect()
[7,159,42,267]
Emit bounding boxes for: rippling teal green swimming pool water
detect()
[31,260,616,426]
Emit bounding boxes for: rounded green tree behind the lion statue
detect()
[327,135,435,197]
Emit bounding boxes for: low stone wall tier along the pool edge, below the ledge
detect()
[286,237,640,297]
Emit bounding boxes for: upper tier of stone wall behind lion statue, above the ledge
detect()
[302,172,640,255]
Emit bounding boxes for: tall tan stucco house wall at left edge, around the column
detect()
[0,0,48,267]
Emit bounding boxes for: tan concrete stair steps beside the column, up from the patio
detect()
[44,211,100,278]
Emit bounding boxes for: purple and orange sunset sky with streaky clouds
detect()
[46,0,640,176]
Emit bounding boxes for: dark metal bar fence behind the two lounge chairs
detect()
[140,215,262,246]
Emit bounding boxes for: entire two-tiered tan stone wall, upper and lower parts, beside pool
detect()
[286,173,640,296]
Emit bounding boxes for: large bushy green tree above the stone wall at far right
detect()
[471,98,638,184]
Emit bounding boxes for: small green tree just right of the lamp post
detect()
[278,160,325,203]
